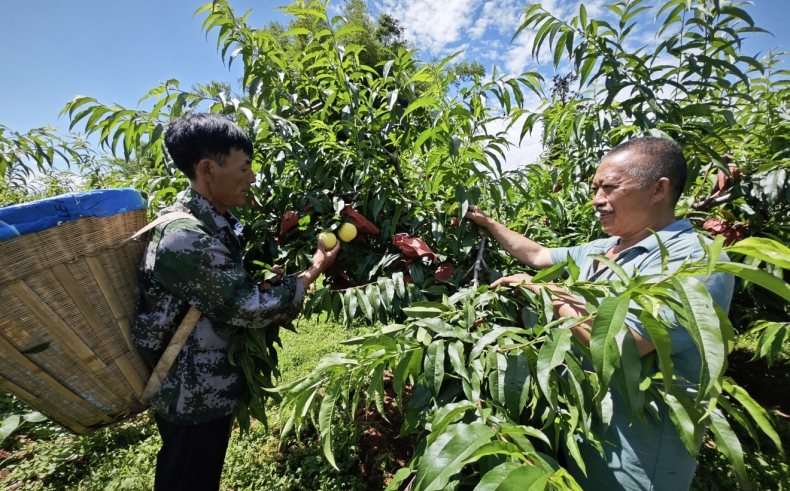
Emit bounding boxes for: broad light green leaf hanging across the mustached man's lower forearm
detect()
[590,295,631,400]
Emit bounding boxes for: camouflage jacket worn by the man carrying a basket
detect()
[132,188,305,424]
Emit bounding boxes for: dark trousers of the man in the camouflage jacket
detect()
[154,414,233,491]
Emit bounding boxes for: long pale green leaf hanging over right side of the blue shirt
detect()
[672,277,727,401]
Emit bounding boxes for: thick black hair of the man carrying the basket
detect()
[165,113,253,181]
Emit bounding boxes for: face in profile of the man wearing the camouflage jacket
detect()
[211,150,255,213]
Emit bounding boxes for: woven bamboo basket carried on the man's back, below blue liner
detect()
[0,210,150,434]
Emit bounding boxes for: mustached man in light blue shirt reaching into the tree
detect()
[466,137,734,491]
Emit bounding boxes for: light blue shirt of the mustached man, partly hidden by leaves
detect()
[549,220,735,491]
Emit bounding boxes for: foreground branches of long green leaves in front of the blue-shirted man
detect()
[280,238,790,490]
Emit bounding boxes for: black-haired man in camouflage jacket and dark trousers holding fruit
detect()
[132,114,339,491]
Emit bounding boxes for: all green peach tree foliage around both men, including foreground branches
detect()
[4,0,790,489]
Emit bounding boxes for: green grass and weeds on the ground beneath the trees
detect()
[0,319,790,491]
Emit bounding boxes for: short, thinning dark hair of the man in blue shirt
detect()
[604,136,688,206]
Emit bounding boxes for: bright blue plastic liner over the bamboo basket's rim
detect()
[0,188,146,240]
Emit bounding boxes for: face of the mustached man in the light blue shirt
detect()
[592,152,657,237]
